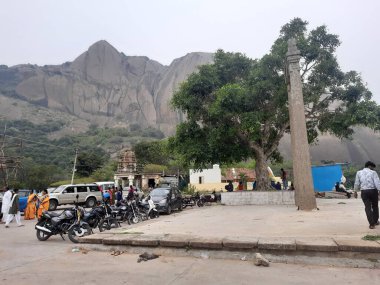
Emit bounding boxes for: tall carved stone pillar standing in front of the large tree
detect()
[286,39,317,210]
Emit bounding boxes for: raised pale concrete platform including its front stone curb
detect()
[79,199,380,268]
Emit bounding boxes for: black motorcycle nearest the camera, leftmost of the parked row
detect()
[35,197,91,243]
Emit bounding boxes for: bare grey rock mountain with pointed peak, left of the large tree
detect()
[0,41,212,134]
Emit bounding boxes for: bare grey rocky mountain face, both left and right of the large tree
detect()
[0,41,380,163]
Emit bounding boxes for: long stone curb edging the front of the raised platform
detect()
[80,233,380,253]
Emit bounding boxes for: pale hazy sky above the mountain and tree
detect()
[0,0,380,102]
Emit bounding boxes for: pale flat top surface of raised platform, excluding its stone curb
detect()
[116,196,380,240]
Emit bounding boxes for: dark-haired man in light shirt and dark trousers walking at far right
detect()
[354,161,380,229]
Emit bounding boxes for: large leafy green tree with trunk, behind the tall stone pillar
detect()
[170,18,380,190]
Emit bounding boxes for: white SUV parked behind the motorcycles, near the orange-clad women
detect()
[49,184,103,211]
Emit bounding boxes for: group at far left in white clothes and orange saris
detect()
[0,187,49,228]
